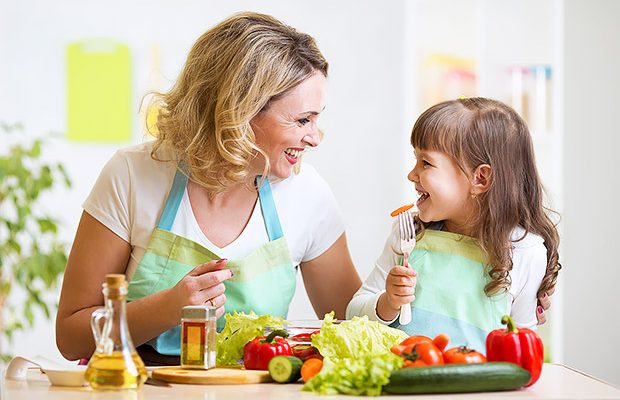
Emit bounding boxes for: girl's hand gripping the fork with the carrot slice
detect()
[377,265,416,321]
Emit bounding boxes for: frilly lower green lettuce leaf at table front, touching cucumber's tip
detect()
[302,352,403,396]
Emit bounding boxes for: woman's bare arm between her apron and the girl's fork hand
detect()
[301,233,362,319]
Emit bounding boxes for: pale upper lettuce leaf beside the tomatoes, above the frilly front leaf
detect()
[312,314,407,358]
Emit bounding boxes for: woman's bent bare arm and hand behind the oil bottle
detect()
[56,212,230,360]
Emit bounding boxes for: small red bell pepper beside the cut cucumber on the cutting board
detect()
[243,330,293,371]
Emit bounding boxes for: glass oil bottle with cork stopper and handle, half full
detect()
[85,274,148,390]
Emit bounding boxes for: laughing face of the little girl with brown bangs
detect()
[407,148,475,235]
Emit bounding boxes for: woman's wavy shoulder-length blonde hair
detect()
[150,12,328,196]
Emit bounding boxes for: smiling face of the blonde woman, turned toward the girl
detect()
[250,72,326,179]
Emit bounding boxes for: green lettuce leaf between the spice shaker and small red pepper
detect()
[216,312,286,366]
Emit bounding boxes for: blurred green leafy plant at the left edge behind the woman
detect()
[0,122,71,362]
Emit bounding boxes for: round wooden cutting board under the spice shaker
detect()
[151,367,272,385]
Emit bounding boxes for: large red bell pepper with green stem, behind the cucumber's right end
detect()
[486,315,544,387]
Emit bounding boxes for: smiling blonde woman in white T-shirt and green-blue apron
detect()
[56,13,361,363]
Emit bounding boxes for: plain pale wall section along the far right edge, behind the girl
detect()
[561,0,620,385]
